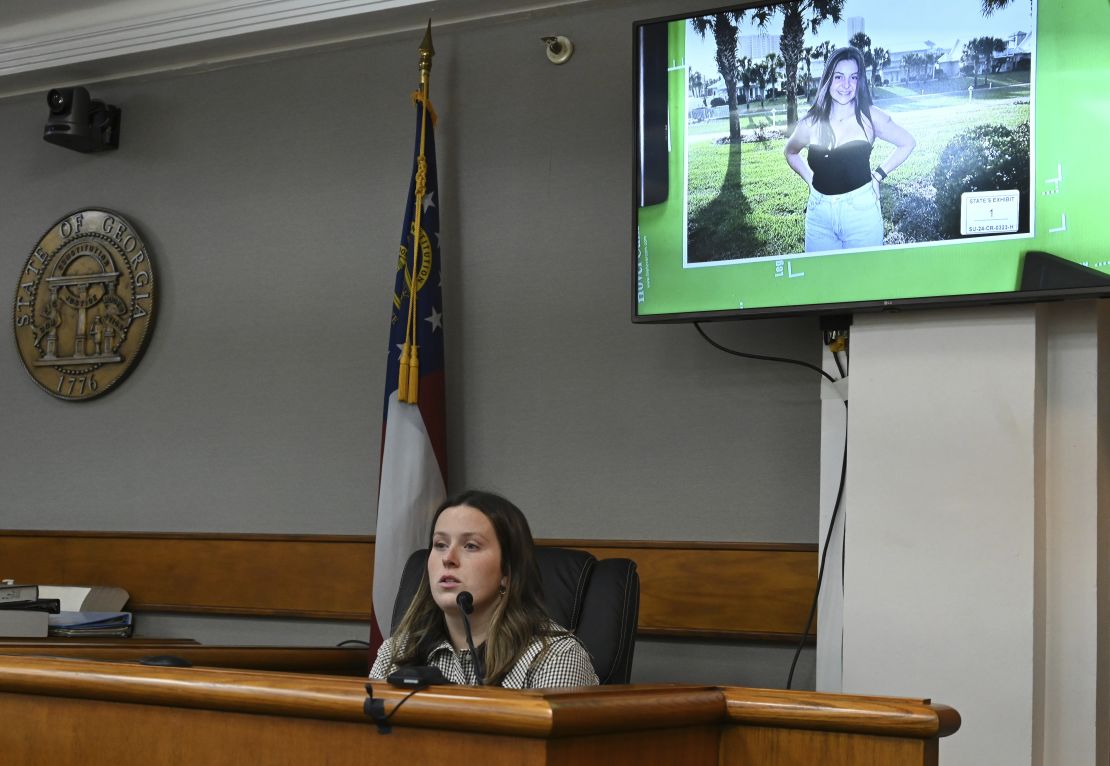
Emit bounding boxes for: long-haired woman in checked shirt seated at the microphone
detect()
[370,491,598,688]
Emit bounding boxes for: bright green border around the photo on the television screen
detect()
[636,0,1110,318]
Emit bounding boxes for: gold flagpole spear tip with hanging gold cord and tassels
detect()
[397,19,435,404]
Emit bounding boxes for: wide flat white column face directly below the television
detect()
[844,305,1037,766]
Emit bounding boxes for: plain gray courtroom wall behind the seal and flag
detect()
[0,2,819,685]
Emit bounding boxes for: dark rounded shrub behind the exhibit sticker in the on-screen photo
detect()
[932,123,1029,238]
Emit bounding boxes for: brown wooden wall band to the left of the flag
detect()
[0,532,373,619]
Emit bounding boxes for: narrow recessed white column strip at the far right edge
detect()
[1033,302,1110,766]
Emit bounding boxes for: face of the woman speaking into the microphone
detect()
[427,505,508,616]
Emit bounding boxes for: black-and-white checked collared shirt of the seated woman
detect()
[370,623,598,689]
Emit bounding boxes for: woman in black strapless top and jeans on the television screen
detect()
[784,48,916,253]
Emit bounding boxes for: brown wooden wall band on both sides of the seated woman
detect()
[0,531,817,641]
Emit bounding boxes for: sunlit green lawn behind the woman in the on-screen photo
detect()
[688,95,1029,261]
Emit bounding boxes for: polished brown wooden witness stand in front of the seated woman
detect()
[0,646,960,766]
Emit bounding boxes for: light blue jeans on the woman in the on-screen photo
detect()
[806,183,882,253]
